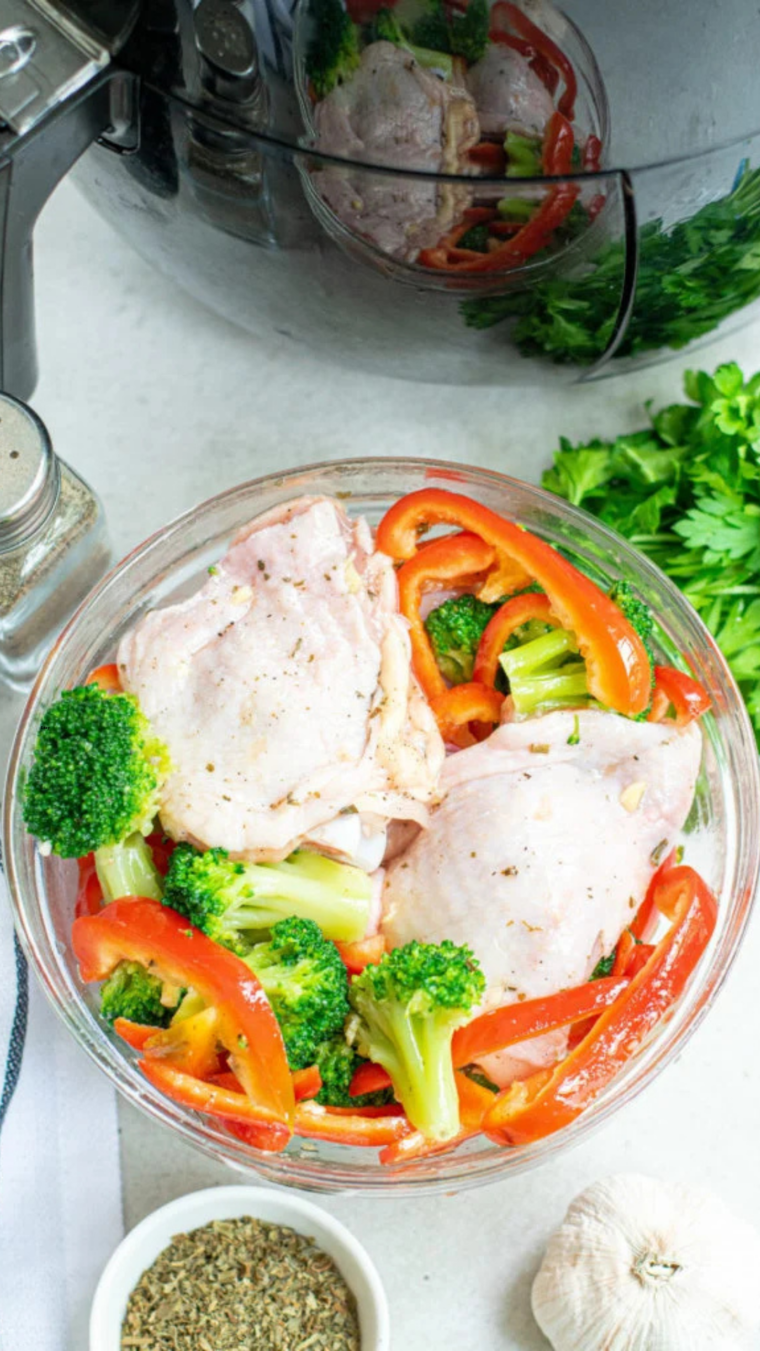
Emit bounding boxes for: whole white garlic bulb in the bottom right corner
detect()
[532,1174,760,1351]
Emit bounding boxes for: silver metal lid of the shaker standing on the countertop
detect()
[0,393,61,554]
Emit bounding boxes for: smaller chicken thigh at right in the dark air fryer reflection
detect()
[467,46,555,138]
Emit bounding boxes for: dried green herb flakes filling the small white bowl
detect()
[121,1216,362,1351]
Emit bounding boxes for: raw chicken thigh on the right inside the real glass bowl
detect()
[382,709,702,1075]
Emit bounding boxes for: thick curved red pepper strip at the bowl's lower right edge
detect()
[483,867,717,1144]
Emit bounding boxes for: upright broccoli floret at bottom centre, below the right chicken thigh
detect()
[348,940,486,1140]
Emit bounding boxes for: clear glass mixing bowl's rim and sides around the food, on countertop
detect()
[4,459,760,1196]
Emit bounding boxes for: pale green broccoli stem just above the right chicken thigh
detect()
[499,628,589,717]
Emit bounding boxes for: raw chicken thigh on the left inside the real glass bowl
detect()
[117,499,443,869]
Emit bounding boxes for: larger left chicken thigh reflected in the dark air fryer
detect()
[315,42,479,259]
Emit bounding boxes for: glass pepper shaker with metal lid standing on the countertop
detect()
[0,393,111,690]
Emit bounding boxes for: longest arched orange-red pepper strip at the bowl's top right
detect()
[377,488,652,717]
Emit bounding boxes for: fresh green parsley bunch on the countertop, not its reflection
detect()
[543,362,760,744]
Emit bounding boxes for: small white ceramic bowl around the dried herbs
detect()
[89,1186,390,1351]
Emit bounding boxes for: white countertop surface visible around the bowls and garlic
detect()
[0,176,760,1351]
